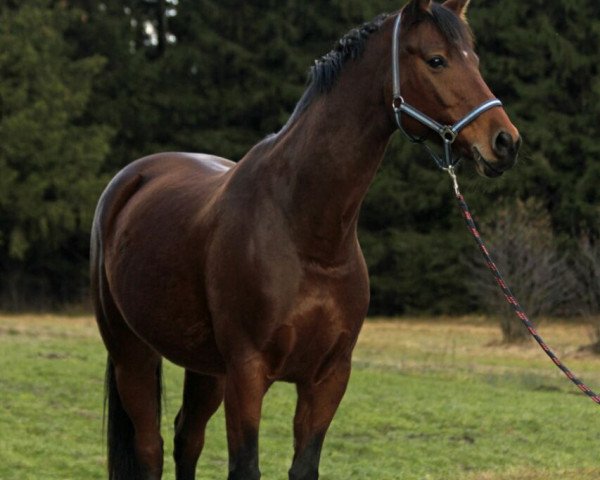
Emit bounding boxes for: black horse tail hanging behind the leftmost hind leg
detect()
[104,357,162,480]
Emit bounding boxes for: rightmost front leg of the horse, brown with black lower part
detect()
[289,359,350,480]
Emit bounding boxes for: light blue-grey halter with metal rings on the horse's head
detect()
[392,12,502,170]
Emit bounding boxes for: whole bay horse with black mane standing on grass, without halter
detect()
[91,0,520,480]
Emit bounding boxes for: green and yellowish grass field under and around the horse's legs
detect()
[0,316,600,480]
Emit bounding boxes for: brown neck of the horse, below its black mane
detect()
[234,32,393,264]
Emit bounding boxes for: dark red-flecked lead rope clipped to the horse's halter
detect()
[444,166,600,405]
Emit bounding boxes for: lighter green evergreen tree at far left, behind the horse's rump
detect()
[0,0,110,306]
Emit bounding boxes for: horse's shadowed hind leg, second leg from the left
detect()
[173,370,224,480]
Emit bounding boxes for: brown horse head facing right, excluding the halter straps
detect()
[390,0,521,177]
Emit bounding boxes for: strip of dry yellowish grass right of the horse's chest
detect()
[354,316,600,387]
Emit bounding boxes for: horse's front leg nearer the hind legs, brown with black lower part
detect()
[225,360,269,480]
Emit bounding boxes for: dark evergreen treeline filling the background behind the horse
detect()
[0,0,600,314]
